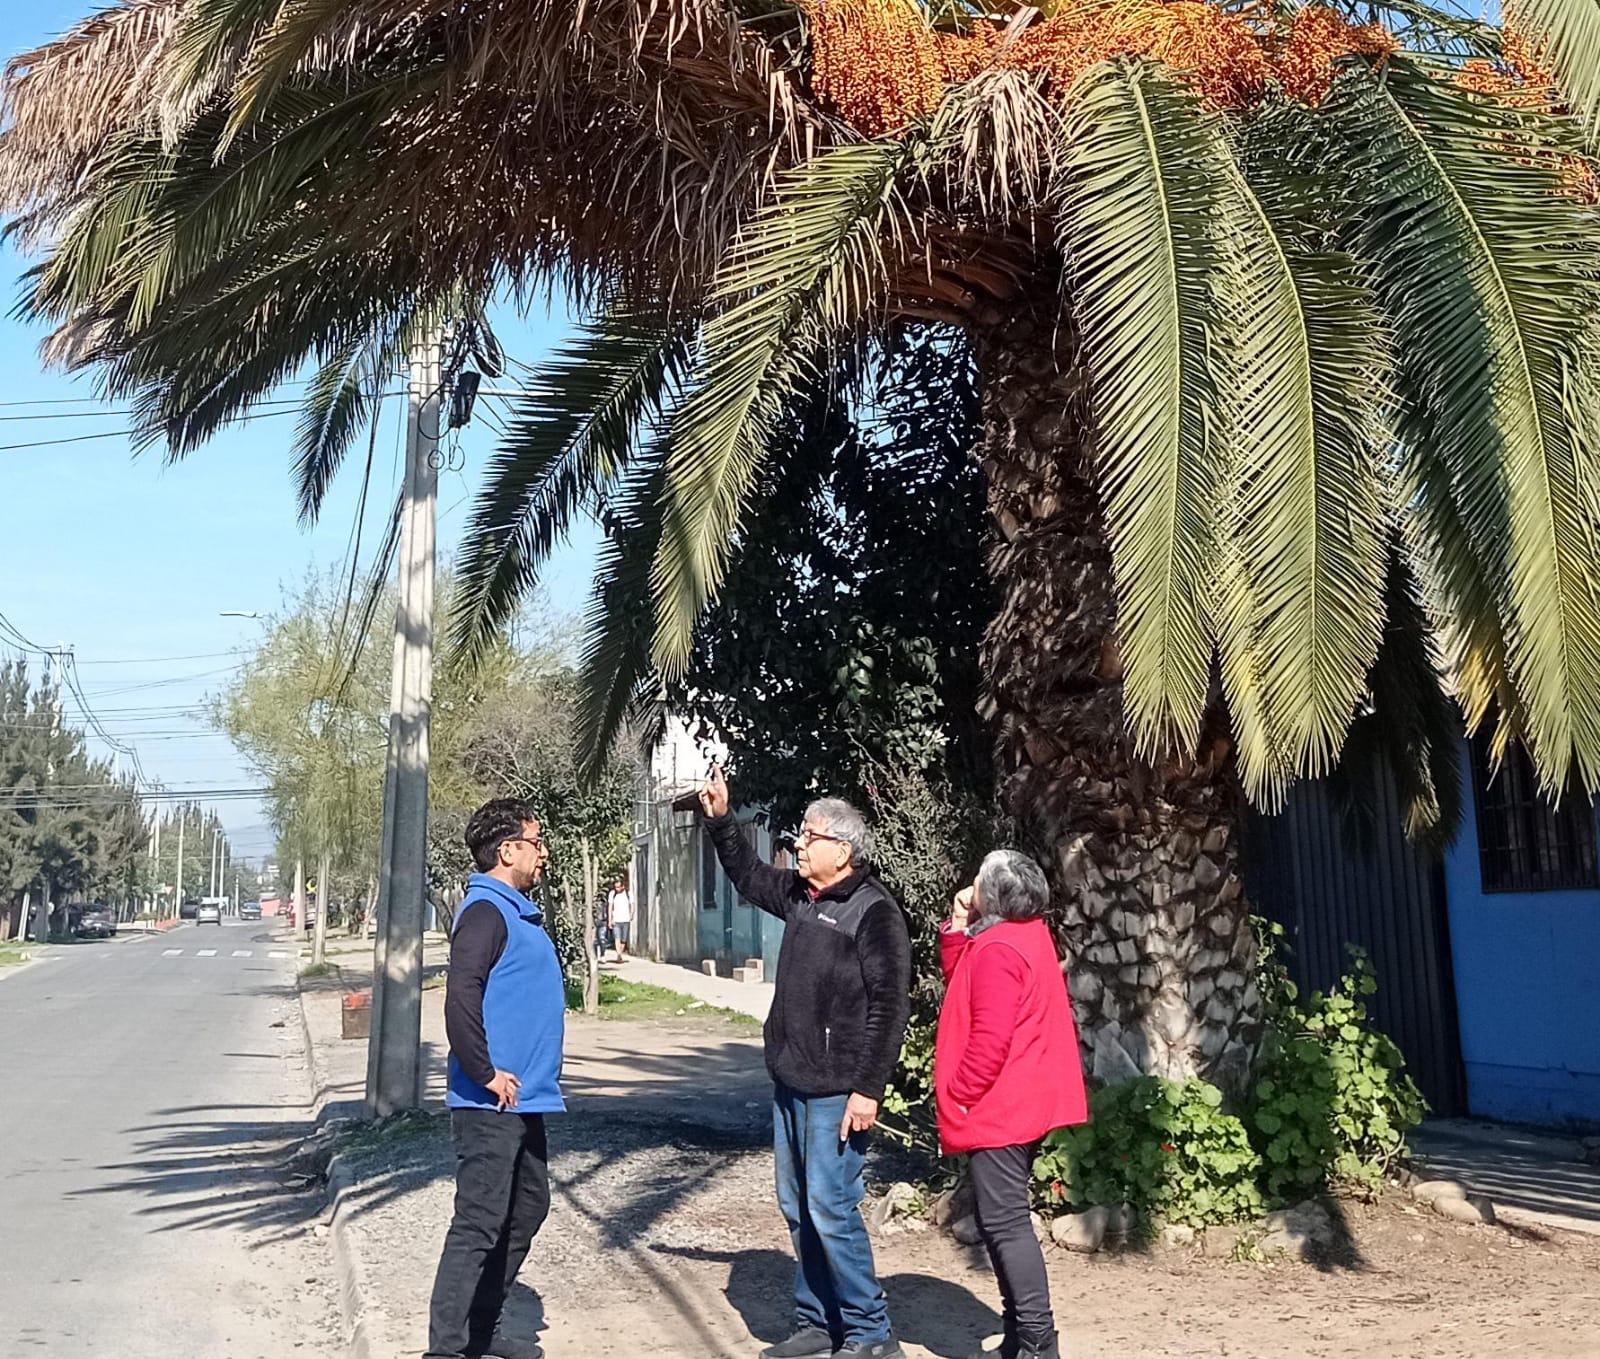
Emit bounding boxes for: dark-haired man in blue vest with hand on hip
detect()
[426,797,566,1359]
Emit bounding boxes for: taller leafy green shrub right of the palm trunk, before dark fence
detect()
[1245,922,1427,1202]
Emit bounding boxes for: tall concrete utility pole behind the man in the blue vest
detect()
[366,328,445,1117]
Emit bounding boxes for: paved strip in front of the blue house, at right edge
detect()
[1410,1119,1600,1236]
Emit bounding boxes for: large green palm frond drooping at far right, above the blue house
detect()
[1325,58,1600,789]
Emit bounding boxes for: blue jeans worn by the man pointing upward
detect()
[773,1085,890,1346]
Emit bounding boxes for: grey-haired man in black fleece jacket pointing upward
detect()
[701,768,910,1359]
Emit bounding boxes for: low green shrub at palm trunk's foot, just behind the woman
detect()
[1034,1076,1261,1226]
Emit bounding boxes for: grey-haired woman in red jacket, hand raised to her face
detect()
[933,850,1088,1359]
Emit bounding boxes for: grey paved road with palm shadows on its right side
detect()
[0,922,338,1359]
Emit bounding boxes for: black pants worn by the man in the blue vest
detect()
[426,1109,550,1359]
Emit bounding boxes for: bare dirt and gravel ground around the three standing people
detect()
[324,1021,1600,1359]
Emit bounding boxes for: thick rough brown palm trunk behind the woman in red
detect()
[978,302,1261,1085]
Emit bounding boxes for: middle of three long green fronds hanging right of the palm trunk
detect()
[1221,126,1394,799]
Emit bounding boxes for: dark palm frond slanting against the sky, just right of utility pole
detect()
[451,303,690,672]
